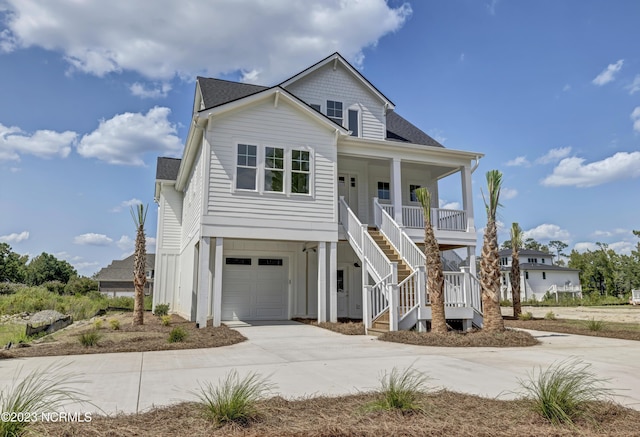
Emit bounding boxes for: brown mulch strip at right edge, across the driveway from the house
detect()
[504,317,640,340]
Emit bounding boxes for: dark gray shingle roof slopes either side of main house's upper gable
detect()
[198,76,444,146]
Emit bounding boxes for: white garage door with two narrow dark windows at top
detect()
[222,256,289,320]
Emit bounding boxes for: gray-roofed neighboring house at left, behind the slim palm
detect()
[96,253,156,297]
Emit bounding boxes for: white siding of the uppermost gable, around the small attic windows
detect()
[287,63,387,140]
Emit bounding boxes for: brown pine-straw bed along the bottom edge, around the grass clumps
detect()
[38,391,640,437]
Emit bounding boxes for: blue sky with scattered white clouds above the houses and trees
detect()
[0,0,640,275]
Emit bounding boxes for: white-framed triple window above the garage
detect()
[235,143,313,196]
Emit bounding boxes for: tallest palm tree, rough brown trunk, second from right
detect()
[480,170,504,331]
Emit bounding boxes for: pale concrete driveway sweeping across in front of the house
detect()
[0,322,640,413]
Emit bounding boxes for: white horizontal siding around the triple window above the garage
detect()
[206,99,337,232]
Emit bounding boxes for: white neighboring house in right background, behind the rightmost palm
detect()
[498,249,582,302]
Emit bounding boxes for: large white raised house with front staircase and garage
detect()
[154,53,483,330]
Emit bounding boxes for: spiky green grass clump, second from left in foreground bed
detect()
[195,370,272,425]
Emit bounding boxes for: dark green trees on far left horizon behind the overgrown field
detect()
[0,243,98,294]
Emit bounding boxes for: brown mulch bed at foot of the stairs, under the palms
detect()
[378,329,540,347]
